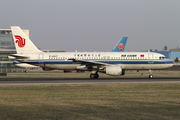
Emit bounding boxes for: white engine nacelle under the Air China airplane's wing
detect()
[106,66,125,75]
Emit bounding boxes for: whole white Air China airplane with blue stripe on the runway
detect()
[8,26,174,79]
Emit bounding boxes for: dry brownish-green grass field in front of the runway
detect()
[0,83,180,120]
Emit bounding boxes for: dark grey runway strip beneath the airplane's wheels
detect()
[0,78,180,85]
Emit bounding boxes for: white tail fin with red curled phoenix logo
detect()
[11,26,42,54]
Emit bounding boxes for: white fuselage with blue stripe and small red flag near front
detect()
[16,52,173,70]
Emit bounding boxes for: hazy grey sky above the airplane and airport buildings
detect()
[0,0,180,52]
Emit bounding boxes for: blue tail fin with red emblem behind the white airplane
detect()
[111,37,128,52]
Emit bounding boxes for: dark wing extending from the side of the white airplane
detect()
[68,59,110,66]
